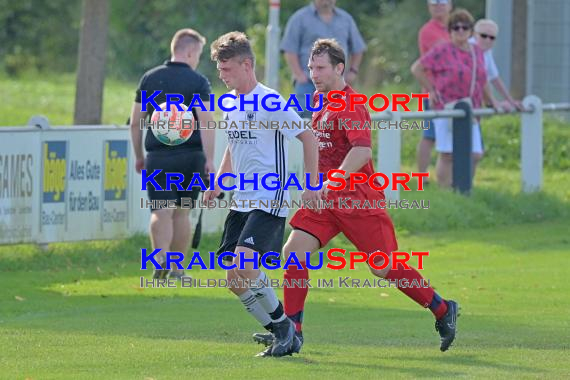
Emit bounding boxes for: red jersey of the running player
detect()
[312,85,385,213]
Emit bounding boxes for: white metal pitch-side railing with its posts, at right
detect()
[372,95,570,199]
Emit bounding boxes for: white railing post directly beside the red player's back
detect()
[376,112,402,201]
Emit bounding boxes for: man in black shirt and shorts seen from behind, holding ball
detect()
[130,29,215,279]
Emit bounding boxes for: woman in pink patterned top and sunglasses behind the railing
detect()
[412,9,498,187]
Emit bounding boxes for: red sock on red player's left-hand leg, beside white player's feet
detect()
[283,261,309,332]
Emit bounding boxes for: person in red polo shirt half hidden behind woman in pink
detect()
[416,0,452,183]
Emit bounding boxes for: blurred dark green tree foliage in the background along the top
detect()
[0,0,485,86]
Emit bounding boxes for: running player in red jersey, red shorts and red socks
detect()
[254,39,458,353]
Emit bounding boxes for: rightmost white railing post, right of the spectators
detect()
[521,95,543,193]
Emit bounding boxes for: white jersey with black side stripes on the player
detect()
[223,83,304,217]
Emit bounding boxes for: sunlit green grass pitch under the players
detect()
[0,221,570,379]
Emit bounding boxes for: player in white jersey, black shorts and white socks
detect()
[204,32,320,356]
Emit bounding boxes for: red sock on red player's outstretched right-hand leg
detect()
[386,265,447,319]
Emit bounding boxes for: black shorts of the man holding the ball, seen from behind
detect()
[145,150,207,211]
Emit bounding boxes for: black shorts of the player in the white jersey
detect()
[214,210,286,261]
